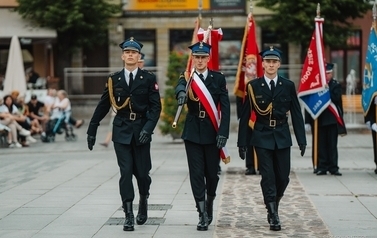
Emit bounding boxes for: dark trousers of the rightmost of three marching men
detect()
[255,147,291,205]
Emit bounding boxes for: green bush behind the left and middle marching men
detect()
[159,51,188,139]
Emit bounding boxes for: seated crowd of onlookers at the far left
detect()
[0,88,84,148]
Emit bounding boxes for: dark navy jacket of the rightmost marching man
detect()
[237,76,306,150]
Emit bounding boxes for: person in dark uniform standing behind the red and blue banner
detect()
[305,63,347,176]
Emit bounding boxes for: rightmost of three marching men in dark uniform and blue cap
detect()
[237,47,306,231]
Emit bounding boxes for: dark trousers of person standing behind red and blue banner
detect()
[318,124,339,173]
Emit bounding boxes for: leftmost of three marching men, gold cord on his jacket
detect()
[87,37,161,231]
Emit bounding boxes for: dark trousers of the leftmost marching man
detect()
[114,139,152,204]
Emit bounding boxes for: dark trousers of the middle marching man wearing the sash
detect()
[185,140,220,202]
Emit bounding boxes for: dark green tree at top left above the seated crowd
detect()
[16,0,121,83]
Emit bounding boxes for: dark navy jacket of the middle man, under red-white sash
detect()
[175,70,230,144]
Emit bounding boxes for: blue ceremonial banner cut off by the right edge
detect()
[361,22,377,115]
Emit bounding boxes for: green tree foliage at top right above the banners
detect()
[257,0,372,49]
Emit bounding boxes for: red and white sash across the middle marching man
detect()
[191,73,230,164]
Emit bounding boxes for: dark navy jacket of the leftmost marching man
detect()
[87,68,161,145]
